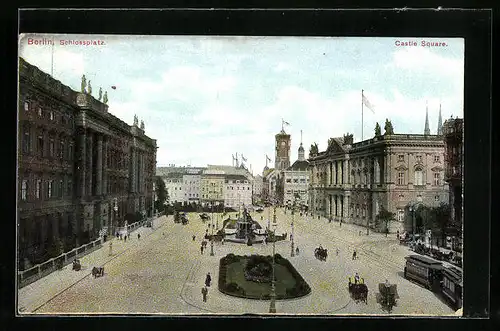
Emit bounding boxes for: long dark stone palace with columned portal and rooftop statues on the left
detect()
[18,58,157,268]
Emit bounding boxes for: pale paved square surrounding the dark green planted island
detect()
[18,208,454,315]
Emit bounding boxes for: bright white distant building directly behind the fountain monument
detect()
[224,175,252,209]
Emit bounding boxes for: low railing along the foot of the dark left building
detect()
[17,238,102,288]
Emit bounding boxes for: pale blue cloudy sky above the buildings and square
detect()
[19,34,464,174]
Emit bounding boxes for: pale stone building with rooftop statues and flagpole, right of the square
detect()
[309,124,448,231]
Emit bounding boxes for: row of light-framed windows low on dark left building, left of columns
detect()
[21,179,73,201]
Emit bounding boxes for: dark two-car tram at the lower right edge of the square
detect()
[404,254,463,309]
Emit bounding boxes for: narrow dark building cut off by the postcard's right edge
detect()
[443,118,464,231]
